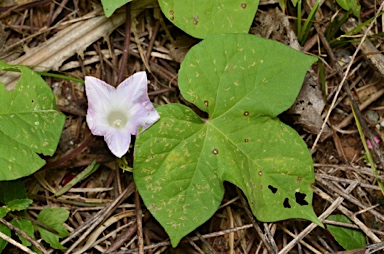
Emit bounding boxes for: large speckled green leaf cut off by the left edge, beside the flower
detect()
[0,61,65,180]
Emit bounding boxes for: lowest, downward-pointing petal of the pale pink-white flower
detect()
[104,128,131,158]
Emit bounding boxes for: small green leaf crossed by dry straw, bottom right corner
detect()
[327,214,367,250]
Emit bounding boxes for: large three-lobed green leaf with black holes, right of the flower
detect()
[133,34,322,246]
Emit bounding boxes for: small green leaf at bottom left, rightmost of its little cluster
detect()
[37,207,69,250]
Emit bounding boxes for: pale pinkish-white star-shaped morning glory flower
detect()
[85,71,160,158]
